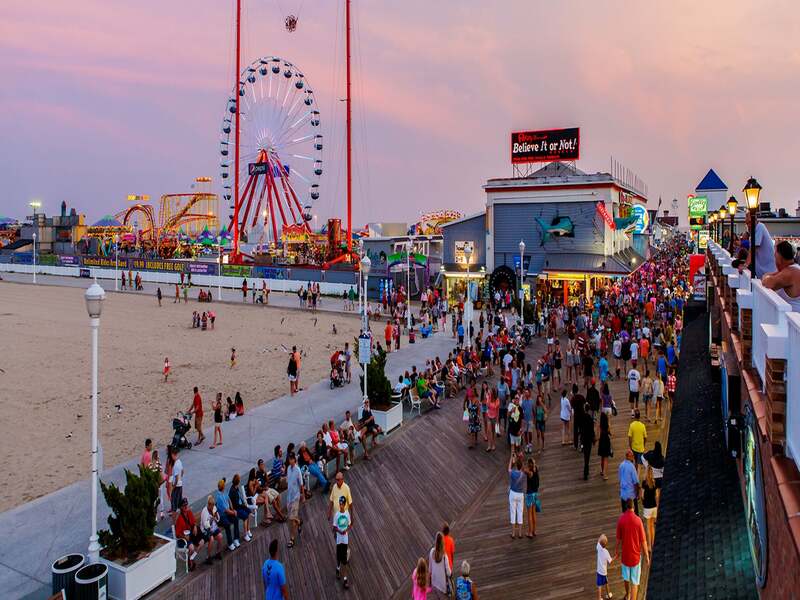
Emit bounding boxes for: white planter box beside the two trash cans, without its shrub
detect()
[100,533,175,600]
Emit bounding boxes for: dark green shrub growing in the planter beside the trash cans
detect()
[98,465,161,560]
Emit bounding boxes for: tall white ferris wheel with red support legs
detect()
[219,56,322,242]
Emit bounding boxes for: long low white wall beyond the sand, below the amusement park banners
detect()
[0,263,353,298]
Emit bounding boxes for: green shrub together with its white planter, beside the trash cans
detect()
[98,465,175,600]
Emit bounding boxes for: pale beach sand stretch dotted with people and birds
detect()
[0,281,359,511]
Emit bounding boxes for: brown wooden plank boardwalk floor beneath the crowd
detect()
[148,340,666,600]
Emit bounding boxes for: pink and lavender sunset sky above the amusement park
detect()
[0,0,800,226]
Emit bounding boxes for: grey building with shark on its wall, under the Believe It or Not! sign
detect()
[442,162,648,299]
